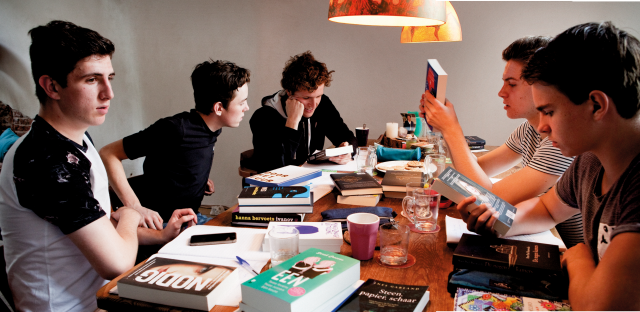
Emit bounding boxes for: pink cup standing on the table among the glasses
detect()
[347,213,380,260]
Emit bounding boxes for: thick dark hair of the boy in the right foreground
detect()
[523,22,640,119]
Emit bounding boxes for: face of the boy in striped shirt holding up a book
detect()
[498,60,537,119]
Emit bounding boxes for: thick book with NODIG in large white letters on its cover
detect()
[118,257,238,311]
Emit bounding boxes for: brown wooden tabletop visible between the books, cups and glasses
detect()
[97,147,519,312]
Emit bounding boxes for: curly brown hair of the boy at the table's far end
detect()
[280,51,335,92]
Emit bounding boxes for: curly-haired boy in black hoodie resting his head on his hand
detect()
[246,51,358,172]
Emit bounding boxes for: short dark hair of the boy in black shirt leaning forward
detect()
[191,59,251,115]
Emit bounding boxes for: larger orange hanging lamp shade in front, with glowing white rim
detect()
[329,0,446,26]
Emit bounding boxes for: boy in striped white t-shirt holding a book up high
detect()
[420,36,583,247]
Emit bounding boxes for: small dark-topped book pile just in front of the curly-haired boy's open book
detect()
[331,173,382,206]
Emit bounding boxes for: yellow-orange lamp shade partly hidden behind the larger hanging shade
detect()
[400,1,462,43]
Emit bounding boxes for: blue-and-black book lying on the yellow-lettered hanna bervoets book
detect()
[236,186,313,214]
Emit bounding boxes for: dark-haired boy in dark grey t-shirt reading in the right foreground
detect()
[458,22,640,311]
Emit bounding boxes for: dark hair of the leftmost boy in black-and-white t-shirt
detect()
[29,21,115,105]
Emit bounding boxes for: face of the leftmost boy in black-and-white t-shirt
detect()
[54,55,115,132]
